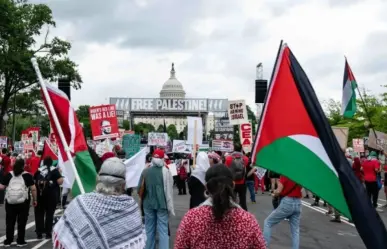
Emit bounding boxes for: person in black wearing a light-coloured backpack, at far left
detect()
[0,159,36,247]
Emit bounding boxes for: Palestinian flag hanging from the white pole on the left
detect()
[42,84,97,196]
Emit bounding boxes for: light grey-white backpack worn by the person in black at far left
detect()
[5,172,28,204]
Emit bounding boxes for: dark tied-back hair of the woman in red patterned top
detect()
[205,164,235,220]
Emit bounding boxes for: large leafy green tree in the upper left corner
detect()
[0,0,82,132]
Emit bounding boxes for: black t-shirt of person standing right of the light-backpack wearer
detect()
[34,168,62,198]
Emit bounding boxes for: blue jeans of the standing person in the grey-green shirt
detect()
[144,208,169,249]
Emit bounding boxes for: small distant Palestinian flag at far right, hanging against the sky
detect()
[341,59,357,118]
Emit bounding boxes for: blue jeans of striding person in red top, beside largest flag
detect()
[263,197,301,249]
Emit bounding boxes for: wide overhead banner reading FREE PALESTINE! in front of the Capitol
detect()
[110,98,227,112]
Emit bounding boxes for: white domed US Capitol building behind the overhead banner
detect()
[134,63,214,135]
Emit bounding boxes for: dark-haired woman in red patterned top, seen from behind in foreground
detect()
[174,164,266,249]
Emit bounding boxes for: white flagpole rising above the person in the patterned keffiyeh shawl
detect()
[31,58,85,194]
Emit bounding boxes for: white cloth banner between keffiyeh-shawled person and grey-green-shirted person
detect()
[124,148,146,188]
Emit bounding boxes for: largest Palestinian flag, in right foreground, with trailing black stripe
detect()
[253,45,387,249]
